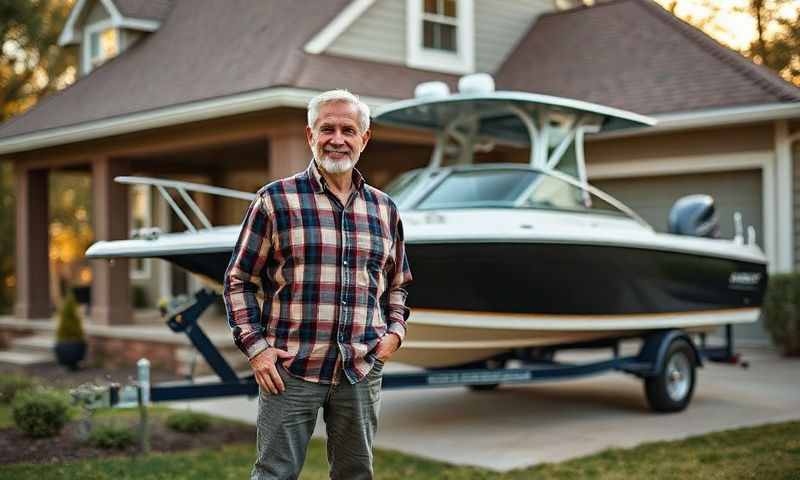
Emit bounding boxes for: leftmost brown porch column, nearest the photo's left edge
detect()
[14,168,51,318]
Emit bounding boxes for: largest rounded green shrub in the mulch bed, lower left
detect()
[11,388,70,437]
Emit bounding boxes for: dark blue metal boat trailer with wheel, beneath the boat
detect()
[73,289,747,412]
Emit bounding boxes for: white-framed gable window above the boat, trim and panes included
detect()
[406,0,468,74]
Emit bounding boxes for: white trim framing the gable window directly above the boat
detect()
[406,0,475,74]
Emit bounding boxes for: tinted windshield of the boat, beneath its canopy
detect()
[416,169,633,217]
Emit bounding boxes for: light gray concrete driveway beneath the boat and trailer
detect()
[169,349,800,471]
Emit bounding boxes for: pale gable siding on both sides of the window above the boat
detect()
[326,0,553,72]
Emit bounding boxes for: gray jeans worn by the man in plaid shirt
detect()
[250,362,383,480]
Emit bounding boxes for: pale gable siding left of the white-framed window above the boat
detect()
[326,0,406,65]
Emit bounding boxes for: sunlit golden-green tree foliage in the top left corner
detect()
[0,0,76,121]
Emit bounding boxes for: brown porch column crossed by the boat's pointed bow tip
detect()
[92,157,133,325]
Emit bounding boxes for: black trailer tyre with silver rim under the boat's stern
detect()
[644,338,697,412]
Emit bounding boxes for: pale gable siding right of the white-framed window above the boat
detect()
[475,0,553,73]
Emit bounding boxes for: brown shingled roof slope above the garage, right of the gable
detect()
[497,0,800,114]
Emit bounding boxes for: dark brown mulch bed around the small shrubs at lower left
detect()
[0,364,256,465]
